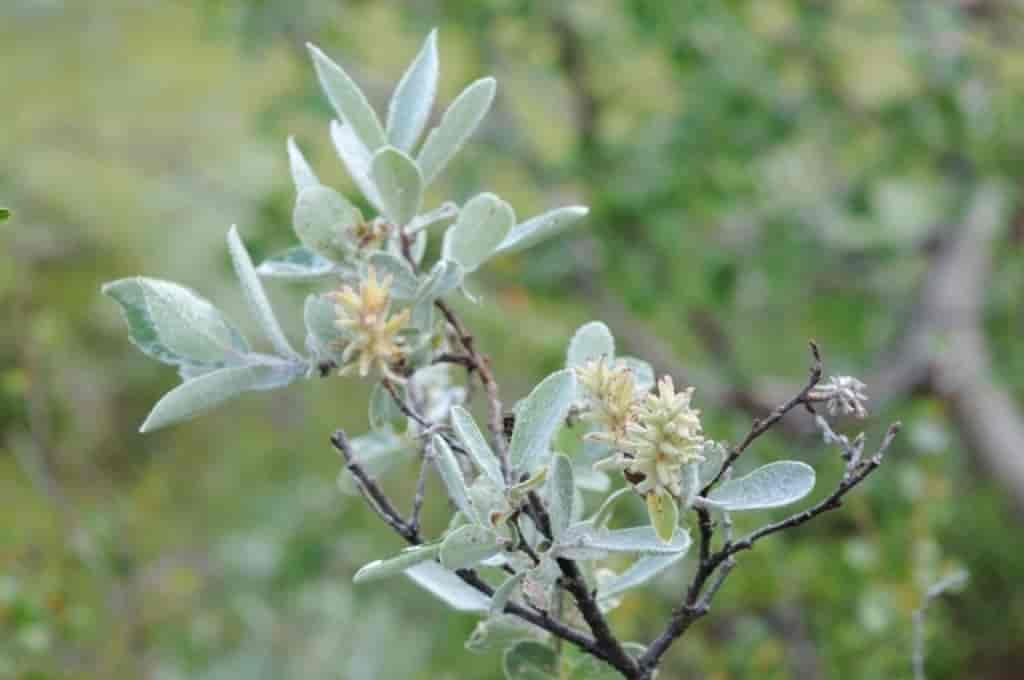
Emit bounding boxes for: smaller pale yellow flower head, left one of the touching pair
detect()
[575,356,637,445]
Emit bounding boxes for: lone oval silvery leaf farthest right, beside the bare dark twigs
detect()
[709,461,814,511]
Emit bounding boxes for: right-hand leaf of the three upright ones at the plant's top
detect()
[417,78,497,185]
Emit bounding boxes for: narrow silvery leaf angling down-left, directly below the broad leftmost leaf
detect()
[139,360,305,432]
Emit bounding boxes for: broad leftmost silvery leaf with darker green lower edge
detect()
[102,277,249,368]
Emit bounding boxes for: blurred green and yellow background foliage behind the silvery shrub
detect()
[0,0,1024,680]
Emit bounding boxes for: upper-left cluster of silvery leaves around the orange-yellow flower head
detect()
[103,29,587,432]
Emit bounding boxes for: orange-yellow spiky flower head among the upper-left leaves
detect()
[330,266,410,379]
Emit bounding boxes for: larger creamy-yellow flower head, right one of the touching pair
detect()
[596,376,705,497]
